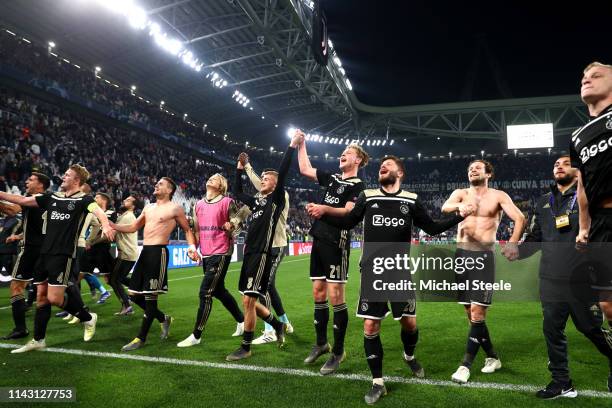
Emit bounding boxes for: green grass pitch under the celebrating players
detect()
[0,251,612,407]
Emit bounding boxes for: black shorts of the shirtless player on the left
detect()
[128,245,168,294]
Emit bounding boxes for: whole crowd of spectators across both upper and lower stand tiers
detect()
[0,31,553,241]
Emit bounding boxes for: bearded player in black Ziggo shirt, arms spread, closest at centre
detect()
[308,156,472,404]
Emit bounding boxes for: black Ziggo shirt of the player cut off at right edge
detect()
[570,105,612,213]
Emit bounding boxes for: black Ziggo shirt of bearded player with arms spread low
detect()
[322,189,463,247]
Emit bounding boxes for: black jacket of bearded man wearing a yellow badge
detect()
[519,184,589,281]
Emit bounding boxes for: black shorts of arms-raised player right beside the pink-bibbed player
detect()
[238,252,273,300]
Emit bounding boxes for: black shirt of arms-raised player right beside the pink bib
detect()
[234,146,295,254]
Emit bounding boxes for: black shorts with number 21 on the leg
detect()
[310,238,350,283]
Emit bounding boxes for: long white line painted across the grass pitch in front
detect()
[0,343,612,399]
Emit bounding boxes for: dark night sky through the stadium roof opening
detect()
[322,0,612,106]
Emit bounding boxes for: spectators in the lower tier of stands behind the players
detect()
[0,83,550,241]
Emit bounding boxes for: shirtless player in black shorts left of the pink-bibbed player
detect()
[111,177,199,351]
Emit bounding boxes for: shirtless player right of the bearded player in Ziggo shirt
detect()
[442,160,525,383]
